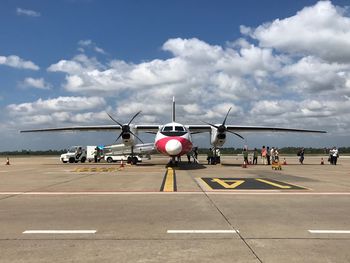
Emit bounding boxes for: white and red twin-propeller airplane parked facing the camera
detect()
[20,97,326,164]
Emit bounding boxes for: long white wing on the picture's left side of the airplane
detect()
[20,125,160,133]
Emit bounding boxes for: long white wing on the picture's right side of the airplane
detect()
[186,124,327,134]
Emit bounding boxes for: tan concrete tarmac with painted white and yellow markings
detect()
[0,156,350,263]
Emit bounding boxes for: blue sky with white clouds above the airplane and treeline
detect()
[0,0,350,151]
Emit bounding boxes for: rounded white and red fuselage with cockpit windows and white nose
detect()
[155,122,193,157]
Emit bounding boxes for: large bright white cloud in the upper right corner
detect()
[246,1,350,62]
